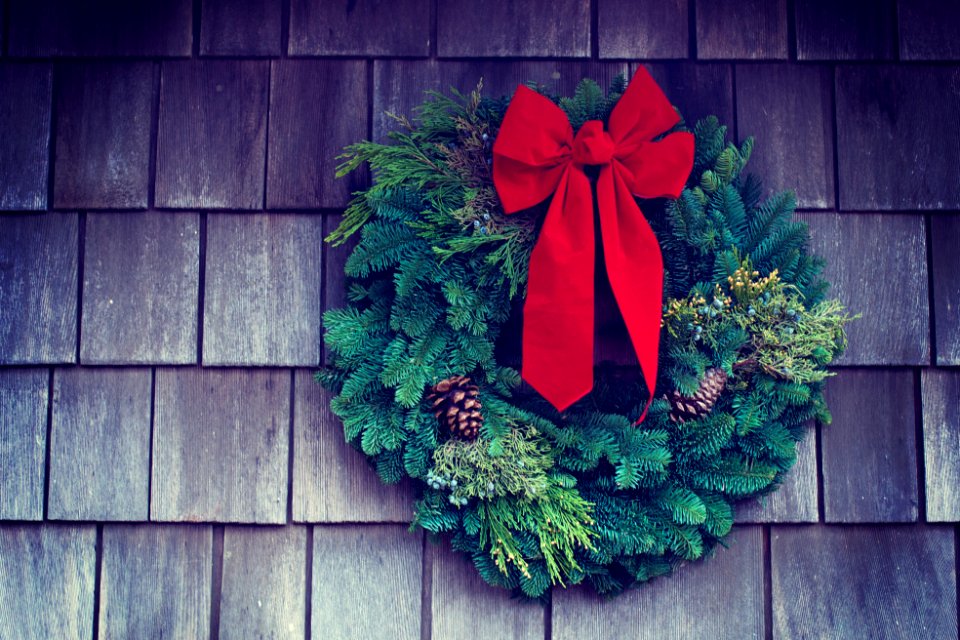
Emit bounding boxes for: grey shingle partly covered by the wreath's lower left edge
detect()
[293,370,415,522]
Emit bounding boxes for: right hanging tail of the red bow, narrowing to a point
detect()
[597,164,663,422]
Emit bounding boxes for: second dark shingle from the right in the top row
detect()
[794,0,897,60]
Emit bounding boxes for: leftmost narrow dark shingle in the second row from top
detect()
[0,63,53,211]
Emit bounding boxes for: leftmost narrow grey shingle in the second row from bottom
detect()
[0,369,50,520]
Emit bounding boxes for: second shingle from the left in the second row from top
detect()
[53,62,158,209]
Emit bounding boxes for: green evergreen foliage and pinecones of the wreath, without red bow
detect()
[318,78,849,599]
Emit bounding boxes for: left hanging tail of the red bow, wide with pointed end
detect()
[523,168,594,411]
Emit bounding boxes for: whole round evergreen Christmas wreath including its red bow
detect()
[318,68,848,599]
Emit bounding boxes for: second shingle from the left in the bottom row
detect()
[99,524,213,639]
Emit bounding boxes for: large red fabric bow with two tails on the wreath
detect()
[493,67,694,420]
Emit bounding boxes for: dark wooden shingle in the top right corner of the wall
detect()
[897,0,960,60]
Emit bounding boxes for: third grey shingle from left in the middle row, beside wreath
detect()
[203,213,323,366]
